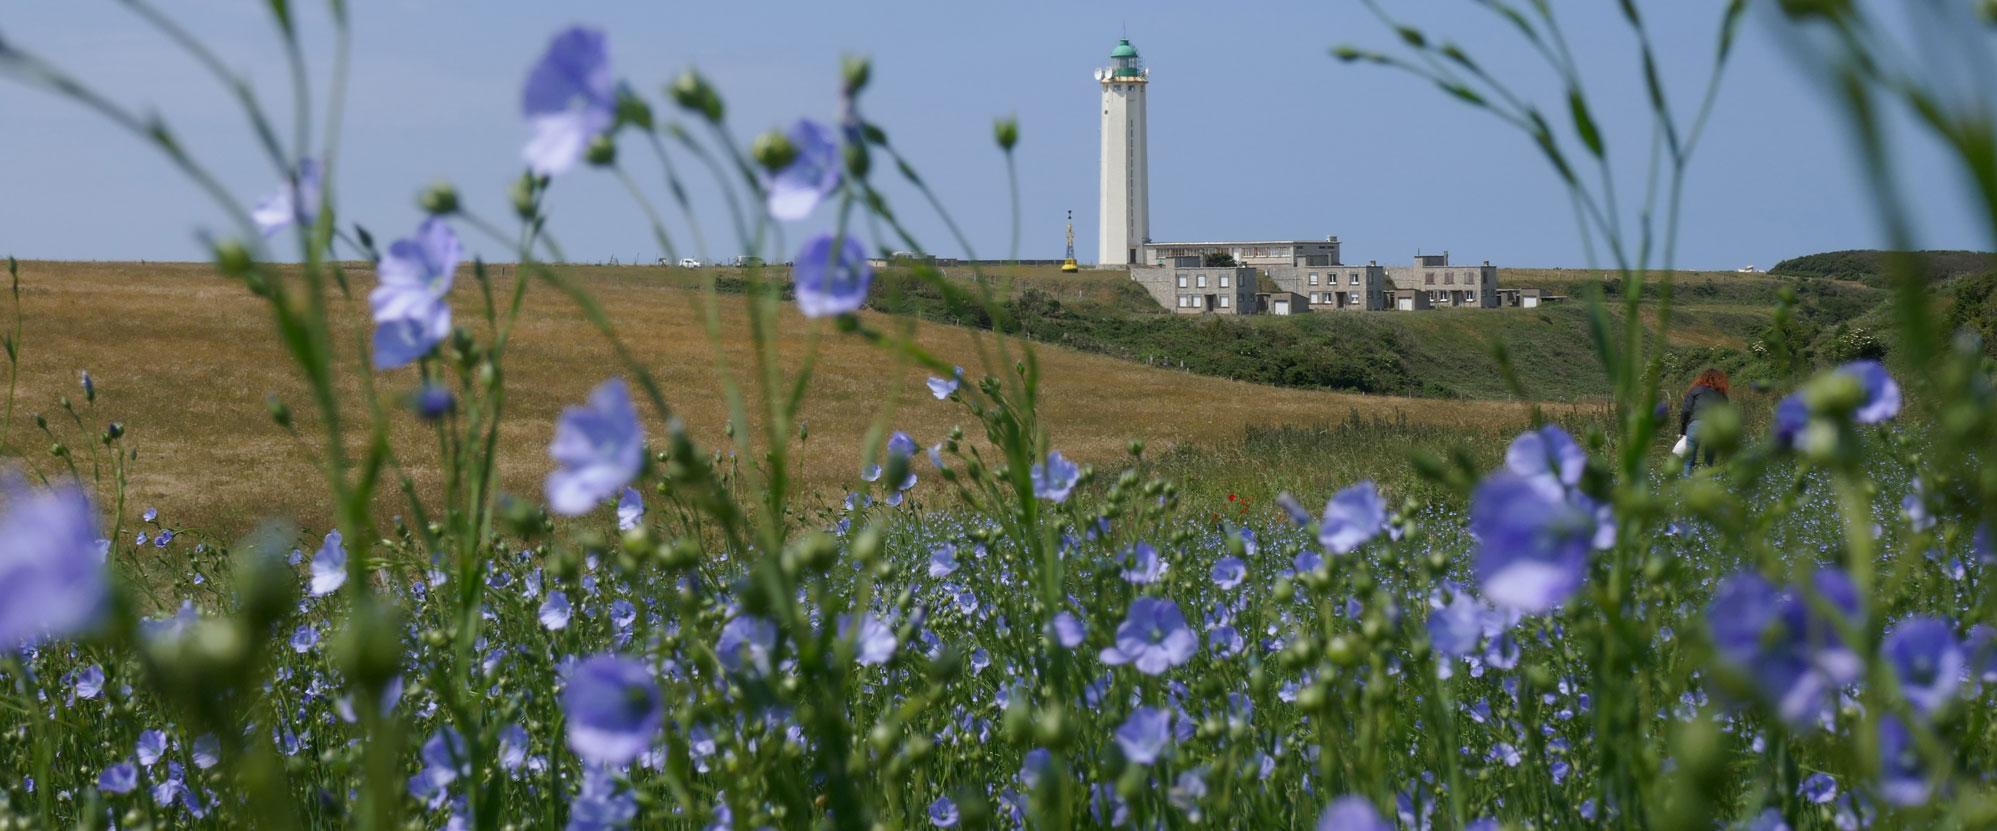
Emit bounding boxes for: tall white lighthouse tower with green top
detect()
[1096,38,1150,266]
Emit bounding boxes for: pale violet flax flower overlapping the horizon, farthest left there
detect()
[367,218,465,370]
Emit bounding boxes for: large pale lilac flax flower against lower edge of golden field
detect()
[547,378,645,517]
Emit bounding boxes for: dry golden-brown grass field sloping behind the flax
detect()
[0,262,1557,533]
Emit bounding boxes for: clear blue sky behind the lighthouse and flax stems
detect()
[0,0,1991,268]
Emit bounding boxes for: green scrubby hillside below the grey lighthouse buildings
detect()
[871,268,1883,402]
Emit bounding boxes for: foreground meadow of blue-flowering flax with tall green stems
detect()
[0,0,1997,831]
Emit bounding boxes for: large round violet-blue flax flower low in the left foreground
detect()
[561,655,665,767]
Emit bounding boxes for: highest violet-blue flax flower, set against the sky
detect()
[519,26,617,176]
